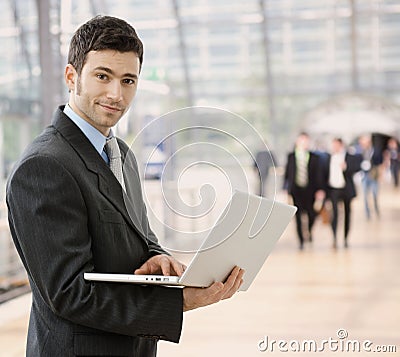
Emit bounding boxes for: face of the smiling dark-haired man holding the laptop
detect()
[65,50,140,136]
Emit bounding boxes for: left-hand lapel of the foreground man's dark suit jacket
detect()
[52,107,147,242]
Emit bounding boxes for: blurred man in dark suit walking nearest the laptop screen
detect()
[284,133,323,250]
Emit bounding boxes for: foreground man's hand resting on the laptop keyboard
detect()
[135,254,186,276]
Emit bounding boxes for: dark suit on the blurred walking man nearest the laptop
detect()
[284,151,323,248]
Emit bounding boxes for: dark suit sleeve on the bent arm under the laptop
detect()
[7,155,182,342]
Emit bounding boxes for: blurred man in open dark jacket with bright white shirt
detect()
[325,138,361,248]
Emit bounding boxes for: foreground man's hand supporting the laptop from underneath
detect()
[183,267,244,311]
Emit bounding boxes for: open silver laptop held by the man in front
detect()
[84,191,297,291]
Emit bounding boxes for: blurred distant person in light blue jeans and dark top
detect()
[358,135,383,219]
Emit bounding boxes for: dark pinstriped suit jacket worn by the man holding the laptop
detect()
[7,107,182,357]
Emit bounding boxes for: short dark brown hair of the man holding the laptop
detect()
[68,15,143,75]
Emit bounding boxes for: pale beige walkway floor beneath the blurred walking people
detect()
[0,182,400,357]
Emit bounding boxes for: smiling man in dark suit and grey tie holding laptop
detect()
[7,16,243,357]
